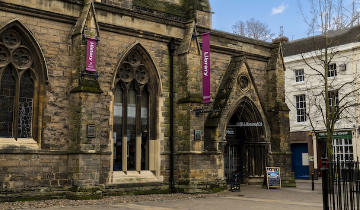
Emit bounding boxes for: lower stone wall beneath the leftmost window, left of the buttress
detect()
[0,153,72,191]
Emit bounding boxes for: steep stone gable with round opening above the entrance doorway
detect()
[205,56,270,150]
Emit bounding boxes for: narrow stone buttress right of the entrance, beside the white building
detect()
[266,38,295,186]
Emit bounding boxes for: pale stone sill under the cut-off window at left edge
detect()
[0,138,40,150]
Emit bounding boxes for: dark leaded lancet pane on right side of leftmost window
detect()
[18,71,34,138]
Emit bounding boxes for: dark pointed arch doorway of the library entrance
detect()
[224,99,267,183]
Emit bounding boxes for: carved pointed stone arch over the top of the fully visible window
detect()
[111,41,162,96]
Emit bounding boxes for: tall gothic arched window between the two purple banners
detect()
[113,45,158,171]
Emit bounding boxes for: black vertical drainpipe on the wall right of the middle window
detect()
[168,38,175,193]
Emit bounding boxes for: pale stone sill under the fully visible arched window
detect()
[110,171,163,184]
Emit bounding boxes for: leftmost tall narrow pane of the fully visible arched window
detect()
[113,85,123,171]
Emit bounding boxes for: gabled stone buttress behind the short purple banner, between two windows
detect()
[69,0,105,188]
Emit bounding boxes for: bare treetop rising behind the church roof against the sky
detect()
[232,18,274,41]
